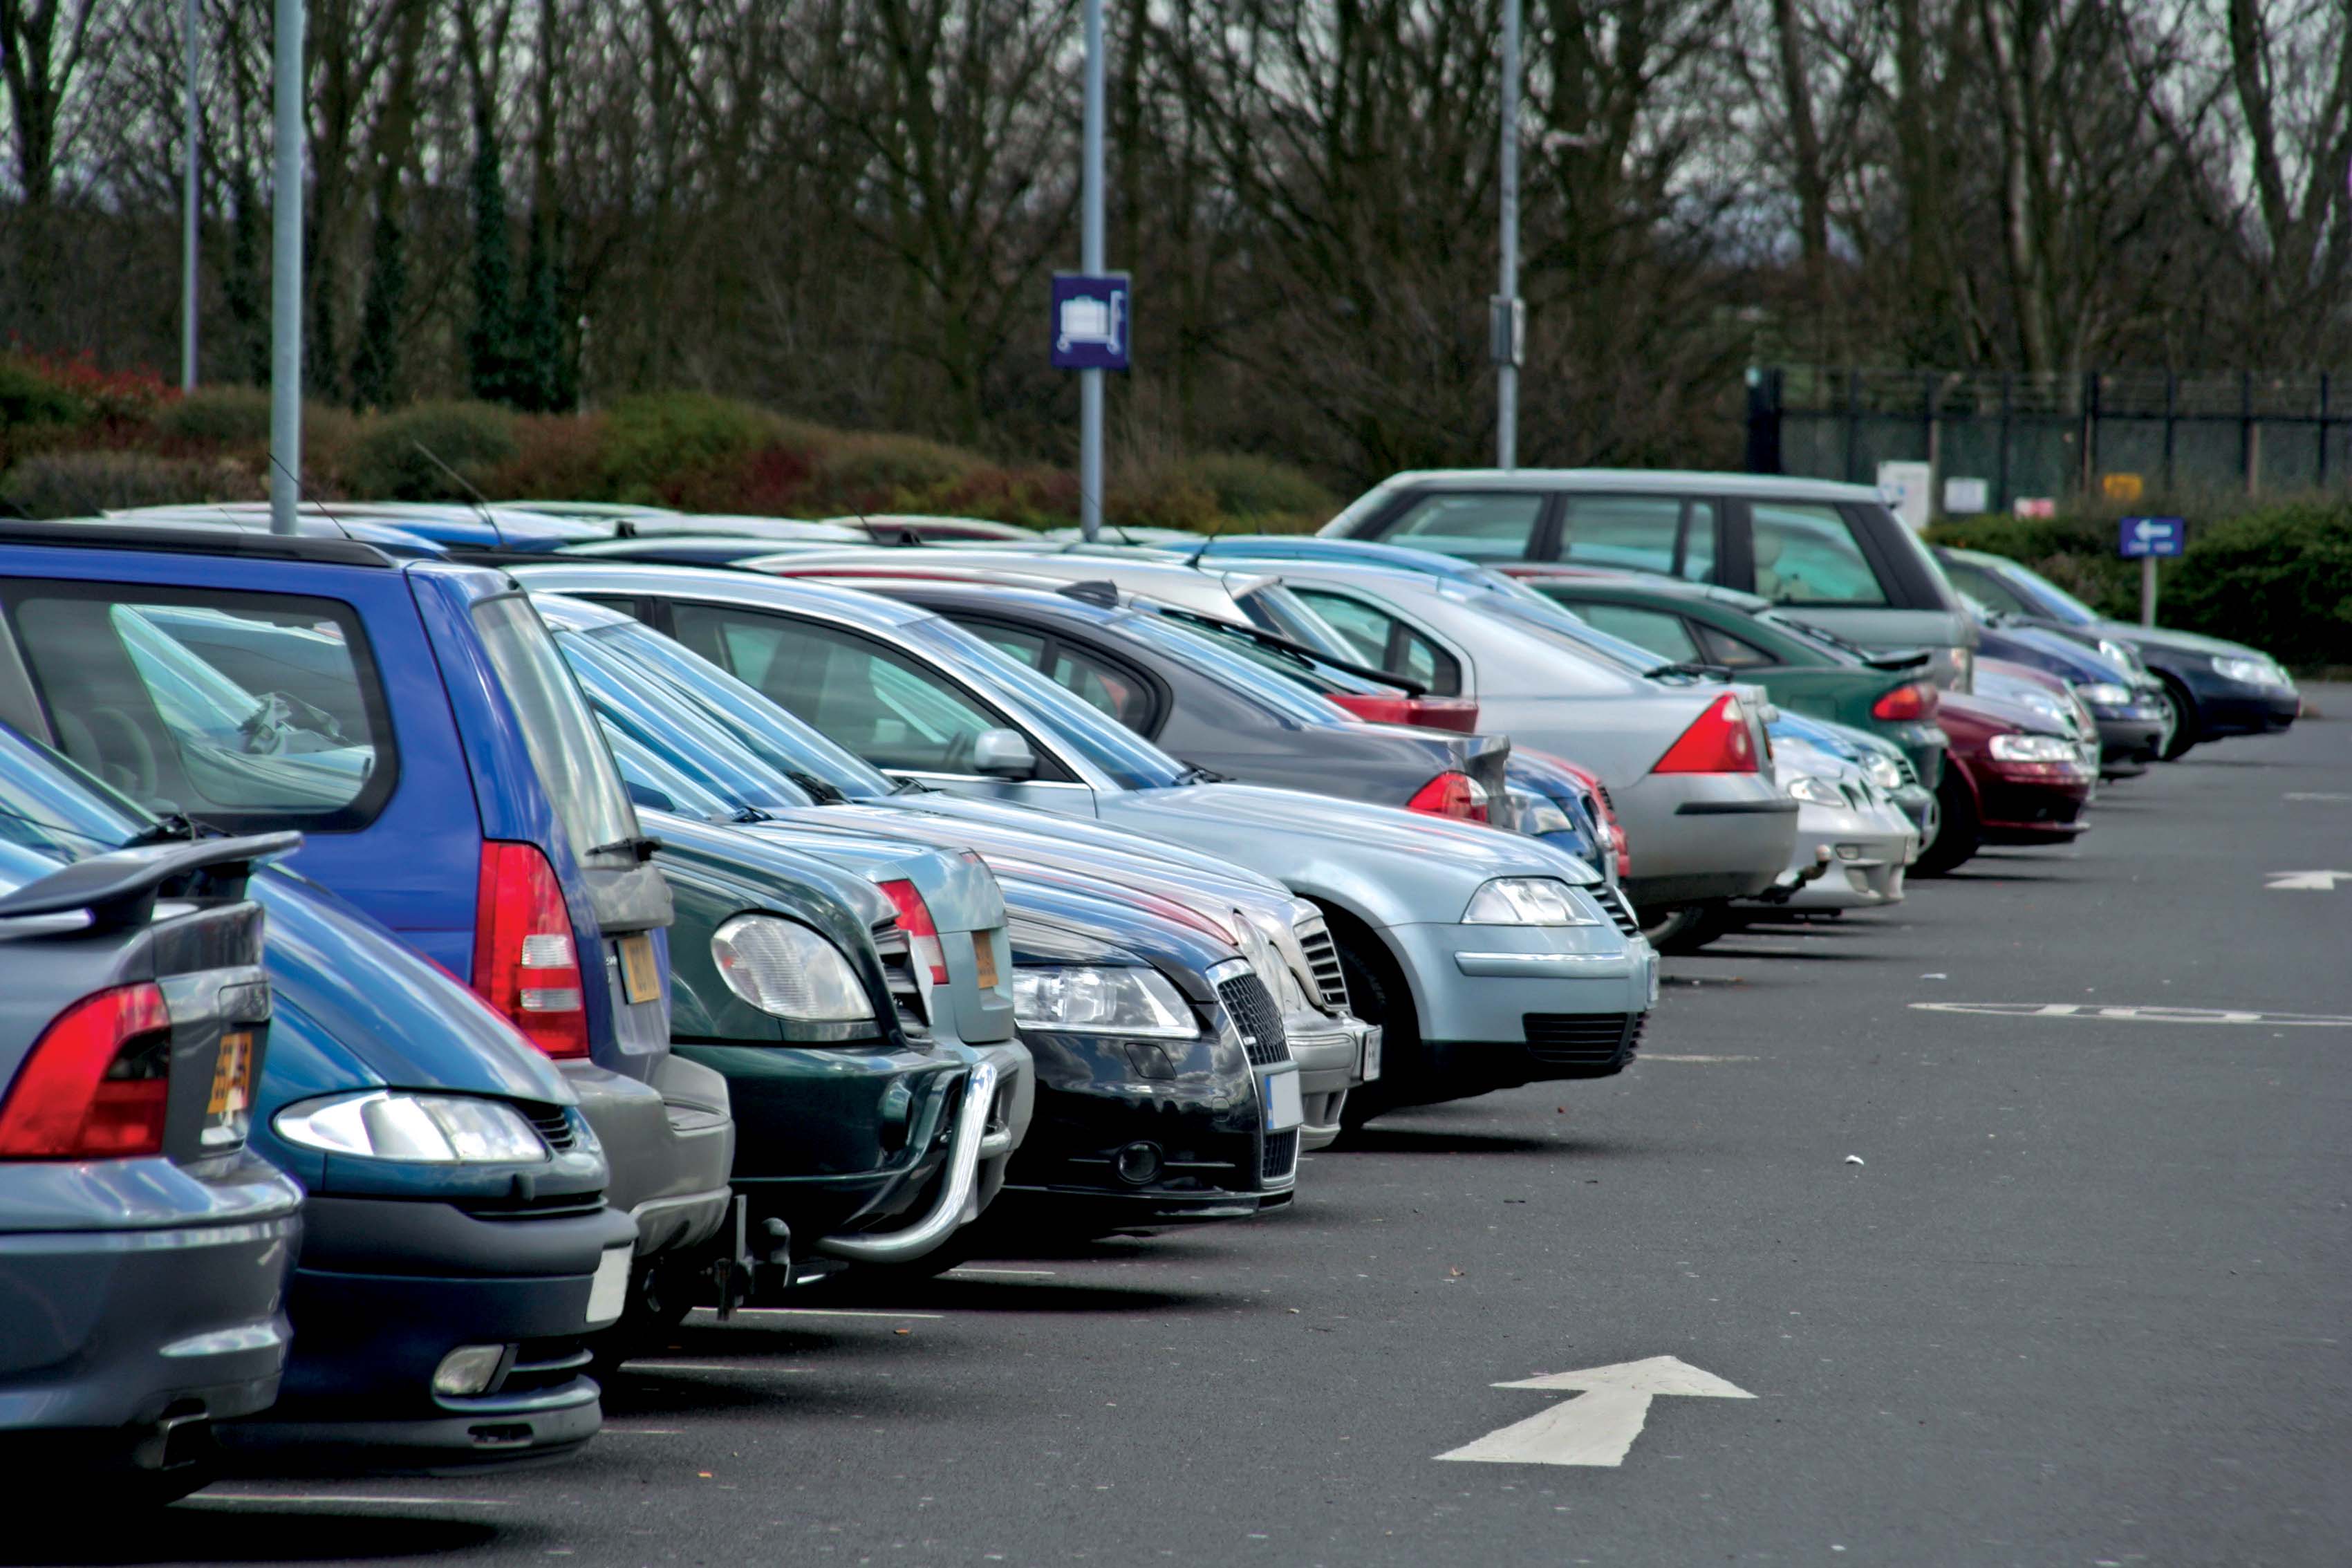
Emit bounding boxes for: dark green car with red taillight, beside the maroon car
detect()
[1503,562,1945,790]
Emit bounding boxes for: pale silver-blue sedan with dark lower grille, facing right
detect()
[515,566,1656,1121]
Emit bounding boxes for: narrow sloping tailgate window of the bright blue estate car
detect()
[473,595,640,861]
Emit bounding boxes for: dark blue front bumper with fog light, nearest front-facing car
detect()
[218,1194,637,1474]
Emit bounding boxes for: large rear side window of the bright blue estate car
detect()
[10,581,398,832]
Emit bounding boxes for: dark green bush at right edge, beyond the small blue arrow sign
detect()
[2159,498,2352,670]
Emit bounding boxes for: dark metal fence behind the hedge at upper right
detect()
[1748,366,2352,512]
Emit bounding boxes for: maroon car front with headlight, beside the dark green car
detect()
[1912,691,2098,877]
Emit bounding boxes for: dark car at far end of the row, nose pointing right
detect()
[1936,550,2303,762]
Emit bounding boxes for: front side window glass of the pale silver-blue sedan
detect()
[671,604,1002,774]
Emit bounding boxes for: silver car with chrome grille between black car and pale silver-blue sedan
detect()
[524,595,1379,1150]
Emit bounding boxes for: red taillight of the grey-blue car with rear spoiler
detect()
[0,980,171,1159]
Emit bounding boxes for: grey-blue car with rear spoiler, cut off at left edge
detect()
[0,780,301,1507]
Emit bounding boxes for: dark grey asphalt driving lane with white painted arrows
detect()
[23,687,2352,1568]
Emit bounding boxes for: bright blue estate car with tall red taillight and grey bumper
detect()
[0,524,734,1325]
